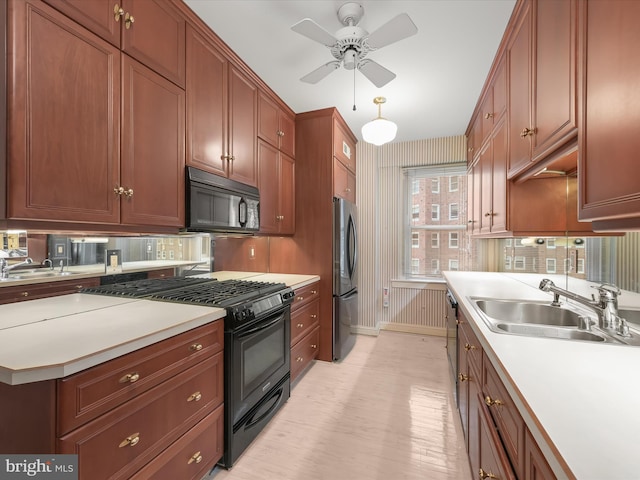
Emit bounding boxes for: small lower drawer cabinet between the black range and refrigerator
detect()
[291,282,320,383]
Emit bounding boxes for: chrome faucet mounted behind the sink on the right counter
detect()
[540,278,628,336]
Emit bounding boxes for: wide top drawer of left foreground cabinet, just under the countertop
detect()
[57,320,224,435]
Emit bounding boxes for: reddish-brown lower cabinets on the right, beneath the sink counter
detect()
[458,312,556,480]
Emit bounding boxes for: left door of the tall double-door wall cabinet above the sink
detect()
[507,2,533,177]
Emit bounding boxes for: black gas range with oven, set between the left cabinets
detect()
[82,277,294,468]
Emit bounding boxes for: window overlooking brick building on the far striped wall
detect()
[398,162,468,277]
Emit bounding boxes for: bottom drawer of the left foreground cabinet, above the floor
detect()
[131,405,224,480]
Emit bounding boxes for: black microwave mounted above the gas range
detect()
[186,167,260,233]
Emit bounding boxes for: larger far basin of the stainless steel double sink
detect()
[475,299,580,327]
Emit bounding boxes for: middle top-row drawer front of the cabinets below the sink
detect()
[482,352,525,477]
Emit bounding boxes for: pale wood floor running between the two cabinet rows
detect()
[203,331,471,480]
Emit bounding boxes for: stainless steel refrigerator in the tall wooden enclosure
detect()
[333,198,358,360]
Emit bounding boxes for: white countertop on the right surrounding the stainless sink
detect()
[445,272,640,480]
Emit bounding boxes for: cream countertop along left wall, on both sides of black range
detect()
[0,266,320,385]
